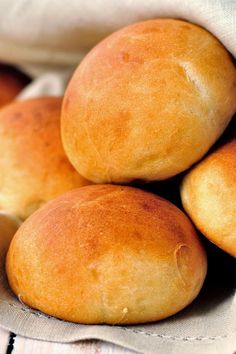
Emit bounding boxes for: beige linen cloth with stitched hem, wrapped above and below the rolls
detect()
[0,0,236,354]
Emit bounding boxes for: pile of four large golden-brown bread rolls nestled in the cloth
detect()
[0,19,236,324]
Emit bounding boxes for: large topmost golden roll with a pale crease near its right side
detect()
[62,19,236,183]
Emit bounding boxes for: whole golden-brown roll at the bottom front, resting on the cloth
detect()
[7,185,207,324]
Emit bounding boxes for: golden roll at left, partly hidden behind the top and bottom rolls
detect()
[0,97,89,219]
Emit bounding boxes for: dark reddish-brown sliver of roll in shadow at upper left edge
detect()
[0,64,29,108]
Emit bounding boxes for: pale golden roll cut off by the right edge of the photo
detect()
[181,138,236,257]
